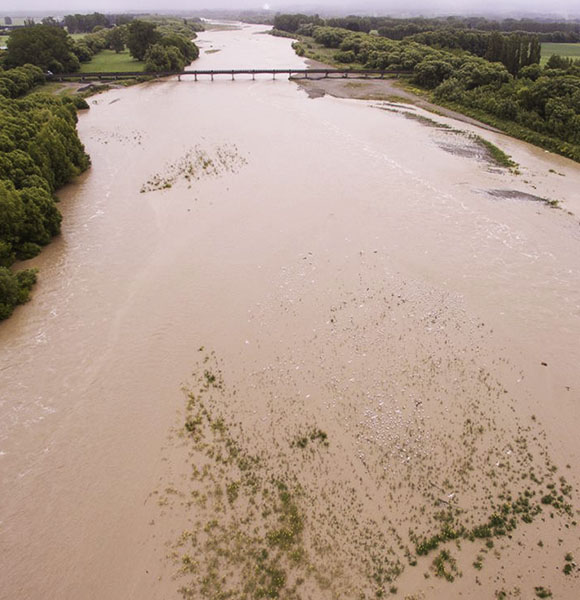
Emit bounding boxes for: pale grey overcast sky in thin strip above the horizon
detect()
[0,0,580,16]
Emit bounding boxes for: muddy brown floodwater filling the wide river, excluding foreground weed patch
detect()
[0,21,580,600]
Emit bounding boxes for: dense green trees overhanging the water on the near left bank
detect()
[0,65,90,320]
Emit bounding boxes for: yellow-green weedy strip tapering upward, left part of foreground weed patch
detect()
[174,355,310,599]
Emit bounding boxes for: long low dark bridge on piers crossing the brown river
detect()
[47,69,412,81]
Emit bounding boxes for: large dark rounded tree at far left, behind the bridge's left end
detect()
[4,25,80,73]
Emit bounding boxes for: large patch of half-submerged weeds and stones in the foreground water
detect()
[152,300,578,600]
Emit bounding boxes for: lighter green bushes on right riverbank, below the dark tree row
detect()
[286,27,580,162]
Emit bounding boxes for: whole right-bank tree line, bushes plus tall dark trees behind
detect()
[273,15,580,161]
